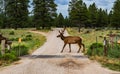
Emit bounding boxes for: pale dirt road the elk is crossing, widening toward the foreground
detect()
[0,29,120,74]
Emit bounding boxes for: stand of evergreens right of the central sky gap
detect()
[69,0,120,29]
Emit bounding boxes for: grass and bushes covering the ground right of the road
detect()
[67,28,120,71]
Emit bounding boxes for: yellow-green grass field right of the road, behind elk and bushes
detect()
[67,28,120,48]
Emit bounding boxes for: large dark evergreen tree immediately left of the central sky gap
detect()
[33,0,57,29]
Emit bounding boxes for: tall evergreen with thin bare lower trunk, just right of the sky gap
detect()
[69,0,87,32]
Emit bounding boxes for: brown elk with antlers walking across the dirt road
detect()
[57,28,85,53]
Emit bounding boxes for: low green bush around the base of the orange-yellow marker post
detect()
[12,45,28,56]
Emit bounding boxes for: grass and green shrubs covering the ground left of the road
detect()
[0,29,46,65]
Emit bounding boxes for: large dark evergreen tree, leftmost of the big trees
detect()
[5,0,29,29]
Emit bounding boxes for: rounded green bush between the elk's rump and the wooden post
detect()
[87,43,103,56]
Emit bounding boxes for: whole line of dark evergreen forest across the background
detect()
[0,0,120,29]
